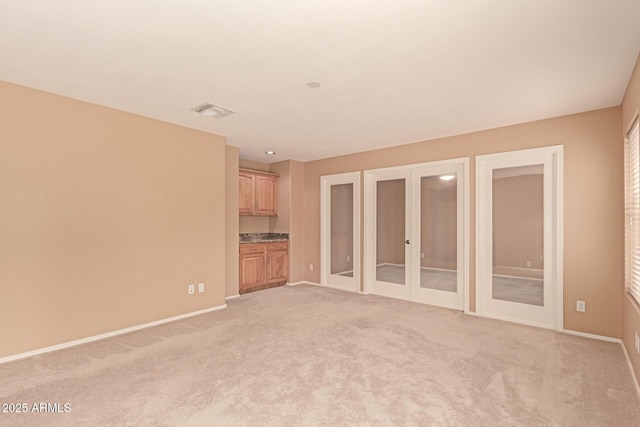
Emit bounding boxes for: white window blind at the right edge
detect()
[624,120,640,304]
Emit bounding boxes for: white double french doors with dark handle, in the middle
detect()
[365,159,468,310]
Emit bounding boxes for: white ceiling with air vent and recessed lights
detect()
[0,0,640,162]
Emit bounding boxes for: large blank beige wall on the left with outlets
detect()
[0,82,225,357]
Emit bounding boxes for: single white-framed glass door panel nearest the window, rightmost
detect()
[476,146,563,329]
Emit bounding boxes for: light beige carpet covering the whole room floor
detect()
[0,285,640,426]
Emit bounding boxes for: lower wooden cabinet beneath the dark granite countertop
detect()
[240,242,289,294]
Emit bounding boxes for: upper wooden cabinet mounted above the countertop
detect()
[238,169,278,216]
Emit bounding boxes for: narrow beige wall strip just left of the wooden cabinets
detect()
[225,145,240,297]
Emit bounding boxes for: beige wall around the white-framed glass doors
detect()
[304,108,622,338]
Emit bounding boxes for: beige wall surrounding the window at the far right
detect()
[612,52,640,384]
